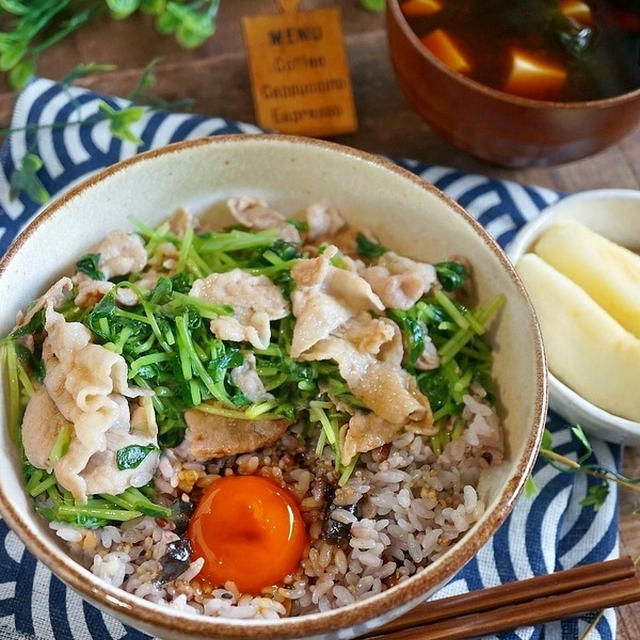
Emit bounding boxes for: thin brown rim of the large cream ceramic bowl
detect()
[0,134,547,638]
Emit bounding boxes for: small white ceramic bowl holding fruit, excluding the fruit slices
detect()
[507,189,640,445]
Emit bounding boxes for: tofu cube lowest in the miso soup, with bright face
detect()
[504,48,567,100]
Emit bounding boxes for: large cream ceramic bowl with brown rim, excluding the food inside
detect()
[0,136,546,640]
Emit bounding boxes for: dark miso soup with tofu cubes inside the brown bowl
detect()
[400,0,640,101]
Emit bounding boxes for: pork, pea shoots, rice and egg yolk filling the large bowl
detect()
[1,196,504,618]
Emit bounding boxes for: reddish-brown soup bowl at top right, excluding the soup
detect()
[387,0,640,167]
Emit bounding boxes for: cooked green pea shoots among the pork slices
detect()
[0,221,505,527]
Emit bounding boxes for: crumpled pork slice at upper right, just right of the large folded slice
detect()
[361,251,437,309]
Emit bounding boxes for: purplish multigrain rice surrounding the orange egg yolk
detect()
[51,385,502,619]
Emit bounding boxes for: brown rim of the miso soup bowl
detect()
[387,0,640,110]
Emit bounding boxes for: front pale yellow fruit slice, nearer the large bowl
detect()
[516,253,640,420]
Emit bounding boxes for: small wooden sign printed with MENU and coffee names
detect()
[243,0,358,136]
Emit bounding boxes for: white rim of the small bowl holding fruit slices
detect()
[506,187,640,441]
